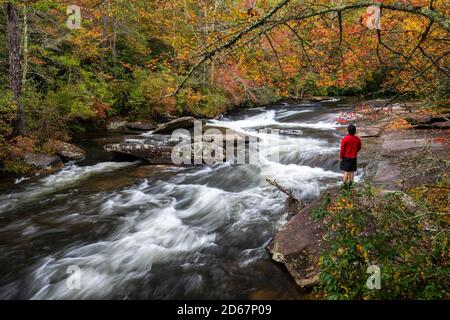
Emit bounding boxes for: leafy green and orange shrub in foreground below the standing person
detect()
[317,187,450,299]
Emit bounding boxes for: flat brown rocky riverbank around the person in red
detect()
[268,101,450,287]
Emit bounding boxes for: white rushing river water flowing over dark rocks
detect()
[0,101,358,299]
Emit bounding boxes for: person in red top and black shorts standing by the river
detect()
[339,124,361,188]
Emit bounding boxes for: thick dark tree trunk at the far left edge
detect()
[5,2,25,136]
